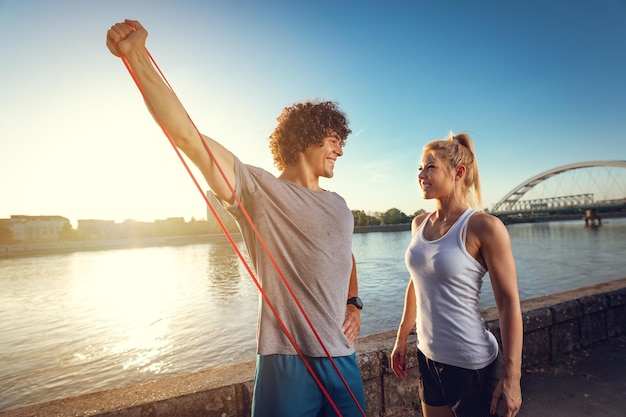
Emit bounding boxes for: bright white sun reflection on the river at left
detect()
[74,249,180,373]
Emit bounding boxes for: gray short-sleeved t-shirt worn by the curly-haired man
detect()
[226,158,354,357]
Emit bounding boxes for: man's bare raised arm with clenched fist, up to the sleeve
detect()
[106,19,235,203]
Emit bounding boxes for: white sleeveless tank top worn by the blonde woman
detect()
[405,208,498,370]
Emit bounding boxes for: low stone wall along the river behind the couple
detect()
[6,278,626,417]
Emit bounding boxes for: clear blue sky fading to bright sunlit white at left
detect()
[0,0,626,223]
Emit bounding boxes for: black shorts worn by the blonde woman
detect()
[417,350,504,417]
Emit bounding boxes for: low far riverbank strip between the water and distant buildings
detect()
[0,223,411,258]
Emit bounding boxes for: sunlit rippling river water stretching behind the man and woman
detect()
[0,219,626,411]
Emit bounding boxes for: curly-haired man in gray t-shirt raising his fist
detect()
[107,20,365,417]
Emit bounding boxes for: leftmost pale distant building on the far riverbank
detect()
[5,215,72,243]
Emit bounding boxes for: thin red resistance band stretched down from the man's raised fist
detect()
[118,45,366,417]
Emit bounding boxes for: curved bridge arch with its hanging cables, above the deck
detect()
[491,161,626,214]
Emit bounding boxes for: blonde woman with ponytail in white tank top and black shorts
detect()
[391,134,523,417]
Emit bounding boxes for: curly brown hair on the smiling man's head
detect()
[269,101,352,171]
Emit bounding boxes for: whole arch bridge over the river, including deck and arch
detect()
[491,161,626,221]
